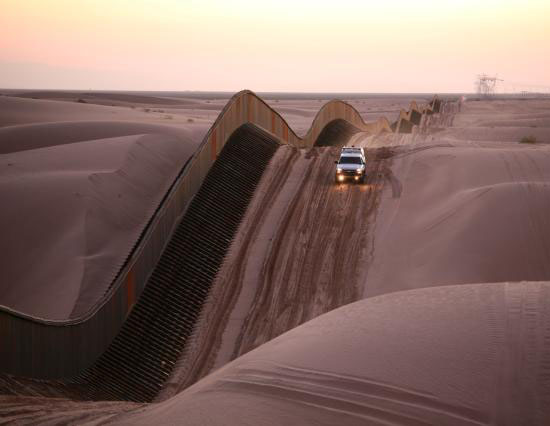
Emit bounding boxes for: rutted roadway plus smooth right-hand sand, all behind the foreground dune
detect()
[154,96,550,422]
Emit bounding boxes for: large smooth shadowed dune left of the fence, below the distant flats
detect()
[0,130,196,319]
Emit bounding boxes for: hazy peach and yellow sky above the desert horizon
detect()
[0,0,550,93]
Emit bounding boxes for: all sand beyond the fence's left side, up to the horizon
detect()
[0,91,422,319]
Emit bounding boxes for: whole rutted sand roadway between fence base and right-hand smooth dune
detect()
[165,146,392,389]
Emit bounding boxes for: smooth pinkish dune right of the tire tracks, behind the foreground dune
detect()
[364,101,550,296]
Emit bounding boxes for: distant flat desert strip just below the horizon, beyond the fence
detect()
[0,91,422,135]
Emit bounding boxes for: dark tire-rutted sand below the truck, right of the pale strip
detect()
[233,148,391,358]
